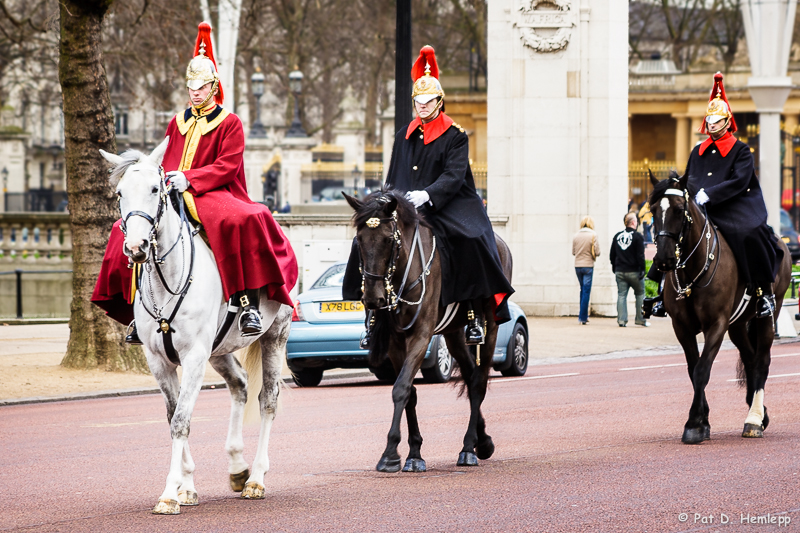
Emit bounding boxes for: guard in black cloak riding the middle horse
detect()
[342,46,514,348]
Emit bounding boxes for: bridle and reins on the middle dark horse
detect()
[359,207,436,331]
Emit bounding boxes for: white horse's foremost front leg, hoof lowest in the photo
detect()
[153,347,208,514]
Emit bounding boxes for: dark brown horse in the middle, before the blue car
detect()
[345,190,511,472]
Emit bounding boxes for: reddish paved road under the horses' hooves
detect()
[0,344,800,533]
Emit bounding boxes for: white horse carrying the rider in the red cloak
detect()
[100,139,291,514]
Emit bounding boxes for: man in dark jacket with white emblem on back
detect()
[610,213,650,328]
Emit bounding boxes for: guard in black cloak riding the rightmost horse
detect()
[643,72,783,318]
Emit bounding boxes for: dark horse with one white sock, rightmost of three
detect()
[650,173,791,444]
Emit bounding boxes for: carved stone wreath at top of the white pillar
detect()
[514,0,574,53]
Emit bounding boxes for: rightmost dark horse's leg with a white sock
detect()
[742,317,775,438]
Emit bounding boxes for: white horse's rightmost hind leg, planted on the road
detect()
[242,305,291,499]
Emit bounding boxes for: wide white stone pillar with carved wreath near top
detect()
[488,0,628,316]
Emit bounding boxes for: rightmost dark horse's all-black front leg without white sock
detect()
[681,318,728,444]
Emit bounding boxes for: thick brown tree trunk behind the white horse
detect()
[58,0,147,371]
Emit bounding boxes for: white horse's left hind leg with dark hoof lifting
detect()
[211,353,250,492]
